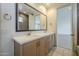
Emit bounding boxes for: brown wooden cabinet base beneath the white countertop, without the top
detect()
[14,36,52,56]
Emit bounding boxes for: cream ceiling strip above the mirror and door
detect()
[36,3,69,9]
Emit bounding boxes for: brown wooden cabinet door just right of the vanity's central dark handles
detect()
[40,36,49,56]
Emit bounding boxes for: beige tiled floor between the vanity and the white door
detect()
[48,48,72,56]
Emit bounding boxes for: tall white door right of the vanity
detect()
[57,5,72,49]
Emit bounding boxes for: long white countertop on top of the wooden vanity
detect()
[13,32,54,45]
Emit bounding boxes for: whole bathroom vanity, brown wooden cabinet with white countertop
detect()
[14,33,55,56]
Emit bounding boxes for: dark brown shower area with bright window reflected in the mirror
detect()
[18,12,29,31]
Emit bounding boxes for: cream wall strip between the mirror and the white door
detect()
[47,8,57,32]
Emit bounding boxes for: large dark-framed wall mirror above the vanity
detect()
[16,3,47,32]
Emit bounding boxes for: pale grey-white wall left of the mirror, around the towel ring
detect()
[1,4,15,55]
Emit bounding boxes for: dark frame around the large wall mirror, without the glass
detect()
[15,3,47,32]
